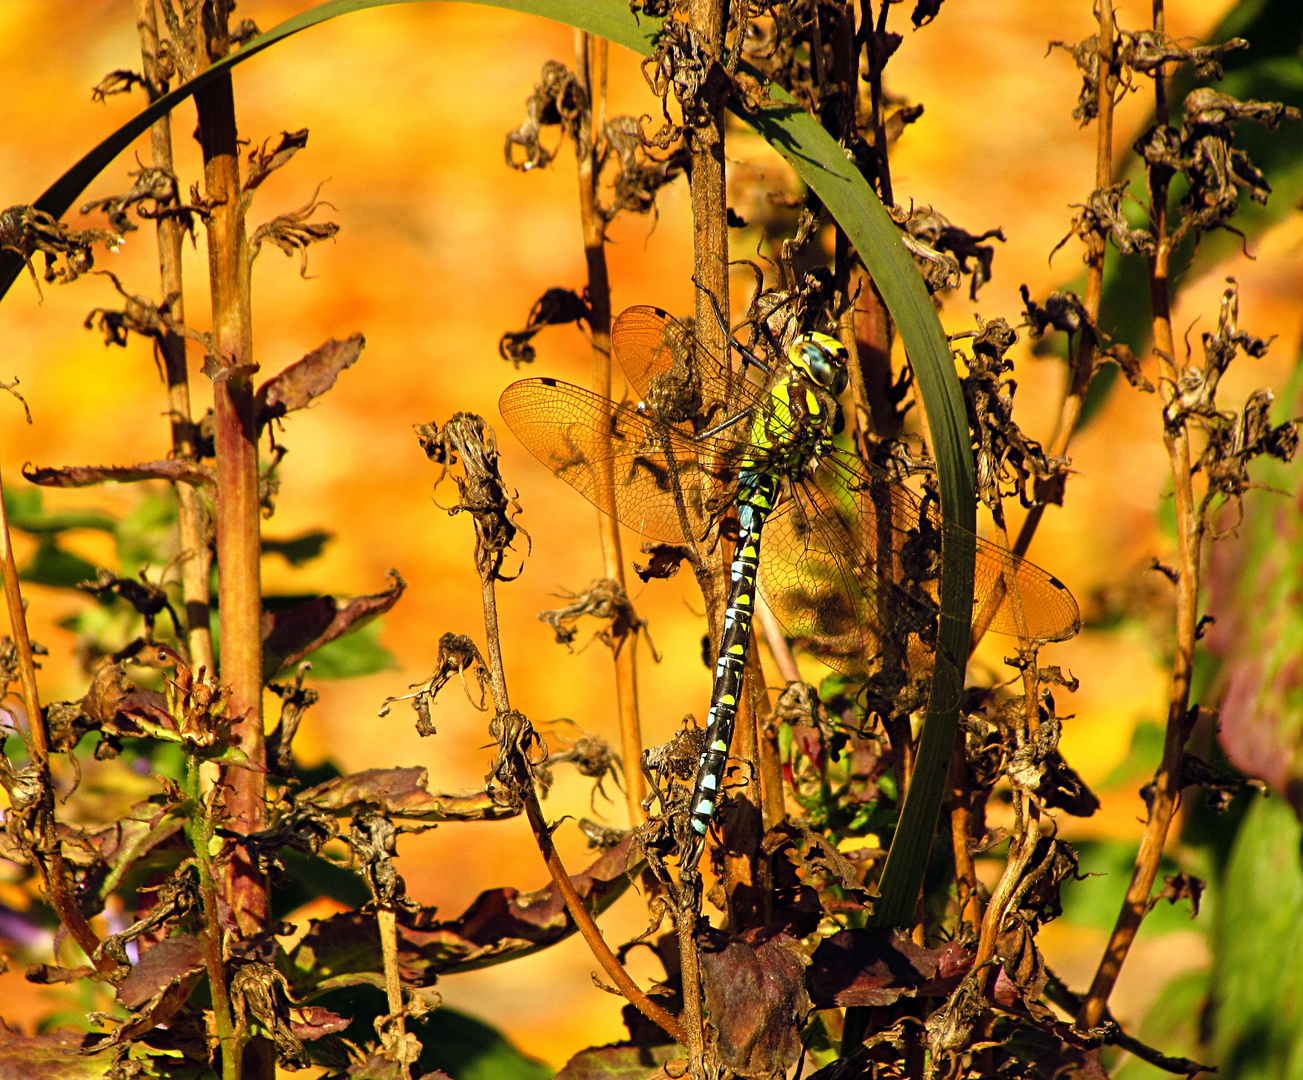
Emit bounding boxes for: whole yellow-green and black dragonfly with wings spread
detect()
[498,306,1080,873]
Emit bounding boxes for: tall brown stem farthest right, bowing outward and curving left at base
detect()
[1078,0,1200,1028]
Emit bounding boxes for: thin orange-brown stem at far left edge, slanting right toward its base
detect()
[0,463,108,974]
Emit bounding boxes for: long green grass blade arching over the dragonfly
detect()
[0,0,976,925]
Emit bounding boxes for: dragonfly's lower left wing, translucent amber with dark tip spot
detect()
[498,379,736,543]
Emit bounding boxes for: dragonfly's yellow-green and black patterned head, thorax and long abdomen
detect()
[680,334,848,870]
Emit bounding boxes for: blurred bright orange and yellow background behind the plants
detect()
[0,0,1303,1066]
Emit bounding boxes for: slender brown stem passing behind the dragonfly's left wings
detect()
[575,31,646,827]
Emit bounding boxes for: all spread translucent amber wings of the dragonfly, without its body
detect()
[500,307,1080,674]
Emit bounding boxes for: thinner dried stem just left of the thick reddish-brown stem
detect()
[136,0,215,672]
